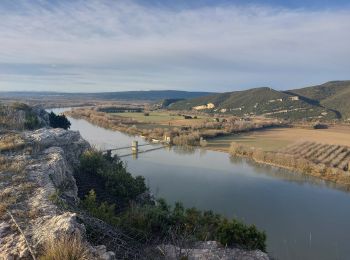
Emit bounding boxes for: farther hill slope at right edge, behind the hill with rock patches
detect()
[288,80,350,119]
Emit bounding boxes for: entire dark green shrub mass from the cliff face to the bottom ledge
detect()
[76,150,266,251]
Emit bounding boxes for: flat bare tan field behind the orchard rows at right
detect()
[207,126,350,152]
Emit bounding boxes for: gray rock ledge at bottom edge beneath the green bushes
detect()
[158,241,269,260]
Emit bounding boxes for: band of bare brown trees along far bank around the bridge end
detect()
[65,107,286,146]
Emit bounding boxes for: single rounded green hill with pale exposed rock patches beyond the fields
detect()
[169,87,339,119]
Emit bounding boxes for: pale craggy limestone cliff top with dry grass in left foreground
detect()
[0,129,113,259]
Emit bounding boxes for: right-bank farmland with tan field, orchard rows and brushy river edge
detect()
[206,125,350,186]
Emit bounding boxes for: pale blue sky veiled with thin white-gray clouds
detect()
[0,0,350,92]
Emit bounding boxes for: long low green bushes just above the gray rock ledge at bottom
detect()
[120,200,266,251]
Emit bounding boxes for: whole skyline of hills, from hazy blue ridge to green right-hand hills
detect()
[0,80,350,120]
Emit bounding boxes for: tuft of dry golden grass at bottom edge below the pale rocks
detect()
[39,235,93,260]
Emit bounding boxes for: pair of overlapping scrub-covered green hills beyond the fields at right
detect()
[168,81,350,120]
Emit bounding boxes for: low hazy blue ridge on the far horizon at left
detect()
[0,90,212,101]
